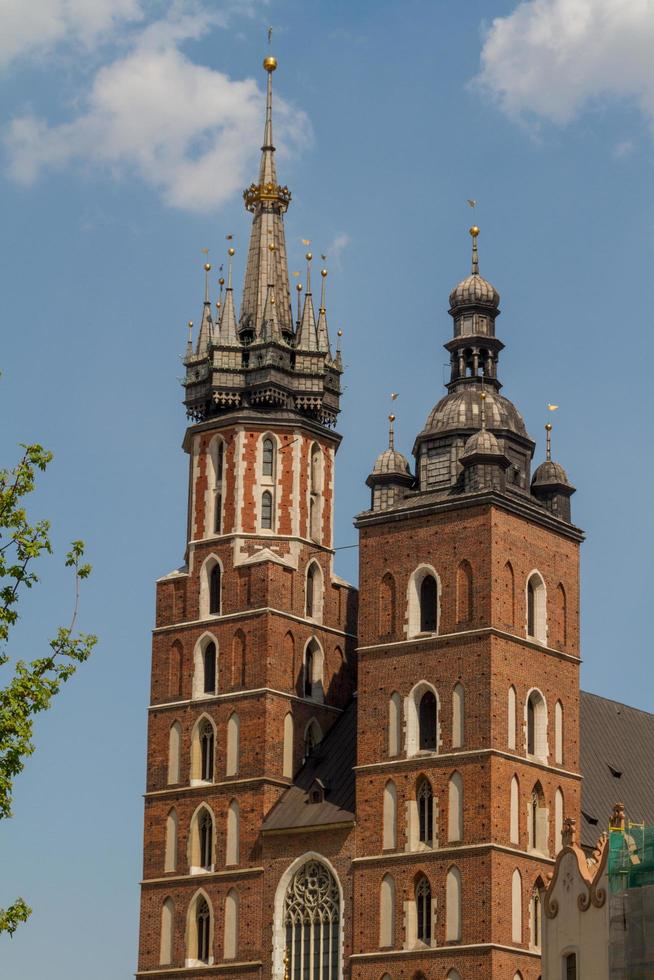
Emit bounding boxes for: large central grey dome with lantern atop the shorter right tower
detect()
[413,225,534,495]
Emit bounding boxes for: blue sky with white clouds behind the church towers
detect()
[0,0,654,980]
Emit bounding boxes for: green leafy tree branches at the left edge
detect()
[0,444,96,935]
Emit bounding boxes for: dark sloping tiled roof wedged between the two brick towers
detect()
[262,700,357,831]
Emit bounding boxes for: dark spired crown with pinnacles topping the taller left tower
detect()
[183,57,343,427]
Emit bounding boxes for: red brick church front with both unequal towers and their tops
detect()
[137,58,583,980]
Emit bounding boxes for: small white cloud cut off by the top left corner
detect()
[0,0,143,68]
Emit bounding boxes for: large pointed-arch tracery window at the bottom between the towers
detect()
[284,861,340,980]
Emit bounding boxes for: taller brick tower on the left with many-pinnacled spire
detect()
[137,57,356,978]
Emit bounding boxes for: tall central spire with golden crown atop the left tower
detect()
[239,57,293,339]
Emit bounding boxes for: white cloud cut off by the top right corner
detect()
[476,0,654,124]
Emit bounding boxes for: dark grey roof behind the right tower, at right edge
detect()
[580,691,654,847]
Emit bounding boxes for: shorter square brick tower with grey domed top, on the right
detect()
[351,227,582,980]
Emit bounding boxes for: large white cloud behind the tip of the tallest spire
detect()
[5,9,309,211]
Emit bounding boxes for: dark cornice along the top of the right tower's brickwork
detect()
[354,490,585,542]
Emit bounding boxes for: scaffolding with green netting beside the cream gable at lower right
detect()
[608,807,654,980]
